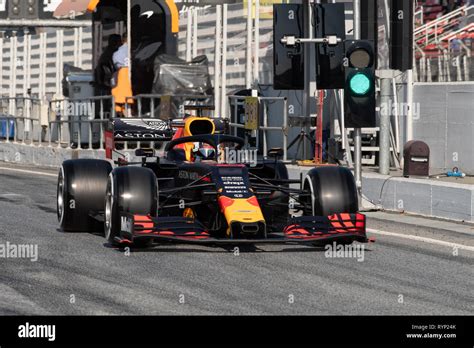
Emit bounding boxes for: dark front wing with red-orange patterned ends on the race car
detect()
[116,213,369,245]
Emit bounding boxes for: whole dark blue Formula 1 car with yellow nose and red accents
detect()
[57,117,368,247]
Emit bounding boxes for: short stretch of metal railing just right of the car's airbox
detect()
[228,95,289,161]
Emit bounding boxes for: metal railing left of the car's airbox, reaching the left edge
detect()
[0,94,218,149]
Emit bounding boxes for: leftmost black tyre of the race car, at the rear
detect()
[56,159,112,232]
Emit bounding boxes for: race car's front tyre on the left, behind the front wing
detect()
[104,167,158,247]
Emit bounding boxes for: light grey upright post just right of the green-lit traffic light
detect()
[379,78,392,175]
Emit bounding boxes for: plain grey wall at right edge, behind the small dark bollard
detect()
[413,83,474,174]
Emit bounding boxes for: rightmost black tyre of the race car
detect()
[303,166,359,216]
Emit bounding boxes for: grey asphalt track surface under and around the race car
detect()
[0,164,474,315]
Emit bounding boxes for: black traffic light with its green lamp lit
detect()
[344,40,376,128]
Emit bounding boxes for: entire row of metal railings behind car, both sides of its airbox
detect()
[0,94,289,161]
